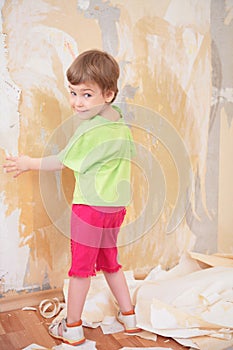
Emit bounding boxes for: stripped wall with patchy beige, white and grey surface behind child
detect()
[0,0,233,293]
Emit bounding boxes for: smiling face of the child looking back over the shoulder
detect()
[69,82,114,119]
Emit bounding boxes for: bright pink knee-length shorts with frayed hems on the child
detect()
[69,204,126,277]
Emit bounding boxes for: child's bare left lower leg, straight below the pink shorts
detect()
[67,276,91,323]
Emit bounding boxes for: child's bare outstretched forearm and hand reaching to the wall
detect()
[3,155,64,177]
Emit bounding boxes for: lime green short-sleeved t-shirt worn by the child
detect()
[58,106,135,206]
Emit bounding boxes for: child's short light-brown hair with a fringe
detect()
[66,50,120,102]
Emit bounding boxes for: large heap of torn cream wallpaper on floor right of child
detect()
[136,254,233,350]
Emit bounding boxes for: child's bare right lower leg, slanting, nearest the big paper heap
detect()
[103,269,133,312]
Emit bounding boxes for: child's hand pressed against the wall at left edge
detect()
[3,156,31,177]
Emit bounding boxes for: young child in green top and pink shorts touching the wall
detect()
[4,50,140,345]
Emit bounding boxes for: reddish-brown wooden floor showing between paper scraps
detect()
[0,310,187,350]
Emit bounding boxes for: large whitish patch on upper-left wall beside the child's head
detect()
[5,0,78,108]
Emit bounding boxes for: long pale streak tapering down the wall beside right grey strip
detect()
[165,0,211,221]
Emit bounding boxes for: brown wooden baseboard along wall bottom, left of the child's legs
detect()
[0,288,64,312]
